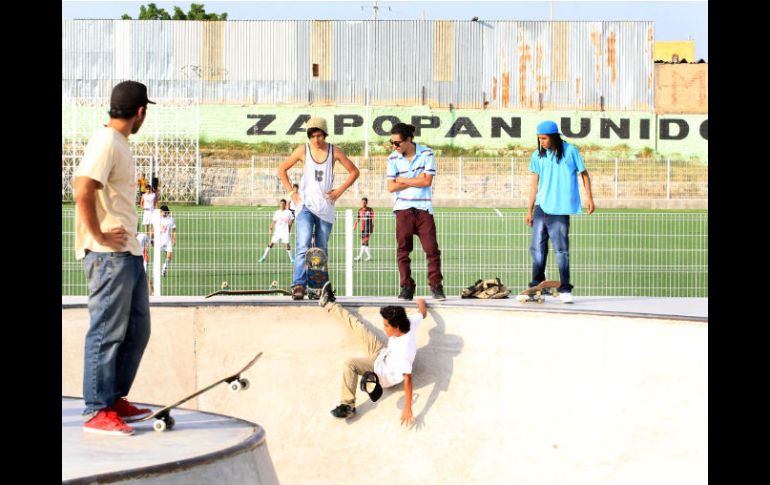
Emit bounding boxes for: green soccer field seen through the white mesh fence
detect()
[62,204,708,297]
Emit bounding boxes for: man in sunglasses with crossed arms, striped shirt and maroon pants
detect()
[386,123,446,300]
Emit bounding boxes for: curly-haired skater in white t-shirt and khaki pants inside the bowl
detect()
[318,282,428,425]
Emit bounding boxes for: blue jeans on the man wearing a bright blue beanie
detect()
[529,205,573,293]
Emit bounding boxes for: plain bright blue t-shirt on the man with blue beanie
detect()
[529,141,586,215]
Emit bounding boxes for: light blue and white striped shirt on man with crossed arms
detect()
[385,143,436,214]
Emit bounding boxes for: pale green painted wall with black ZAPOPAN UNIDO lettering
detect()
[200,105,708,161]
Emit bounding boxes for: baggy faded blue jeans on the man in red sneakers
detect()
[83,251,150,419]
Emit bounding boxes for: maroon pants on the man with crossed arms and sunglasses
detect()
[396,209,444,288]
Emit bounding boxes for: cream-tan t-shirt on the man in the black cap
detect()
[75,126,142,259]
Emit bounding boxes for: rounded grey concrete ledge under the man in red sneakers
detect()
[62,397,278,485]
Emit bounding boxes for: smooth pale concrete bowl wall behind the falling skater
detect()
[62,306,708,484]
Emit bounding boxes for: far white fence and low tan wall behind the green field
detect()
[190,157,708,207]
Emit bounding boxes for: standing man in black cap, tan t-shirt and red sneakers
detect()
[73,81,154,436]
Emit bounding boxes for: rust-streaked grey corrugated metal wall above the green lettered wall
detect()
[62,20,654,111]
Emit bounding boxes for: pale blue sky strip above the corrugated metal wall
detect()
[62,0,708,61]
